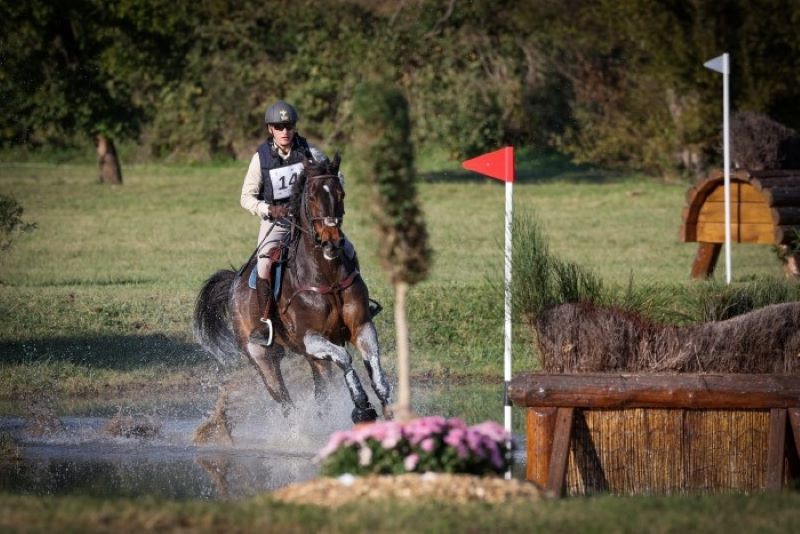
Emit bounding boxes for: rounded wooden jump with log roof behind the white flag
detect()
[680,170,800,278]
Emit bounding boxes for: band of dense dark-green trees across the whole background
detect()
[0,0,800,173]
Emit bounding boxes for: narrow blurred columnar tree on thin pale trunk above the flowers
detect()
[353,82,431,420]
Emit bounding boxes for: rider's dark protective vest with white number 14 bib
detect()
[258,135,313,204]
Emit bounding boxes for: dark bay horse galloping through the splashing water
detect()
[193,154,392,423]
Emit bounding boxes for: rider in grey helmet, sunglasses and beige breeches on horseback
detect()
[241,100,357,346]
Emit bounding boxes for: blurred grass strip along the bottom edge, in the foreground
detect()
[0,494,800,533]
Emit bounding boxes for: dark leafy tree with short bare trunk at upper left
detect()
[0,0,199,177]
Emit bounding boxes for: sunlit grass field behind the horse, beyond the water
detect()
[0,155,780,397]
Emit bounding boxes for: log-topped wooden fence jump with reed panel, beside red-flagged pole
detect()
[509,373,800,495]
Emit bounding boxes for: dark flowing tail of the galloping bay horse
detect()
[192,270,242,365]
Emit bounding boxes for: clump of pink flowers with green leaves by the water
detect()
[317,416,510,476]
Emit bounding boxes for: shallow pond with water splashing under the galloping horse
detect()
[0,381,525,500]
